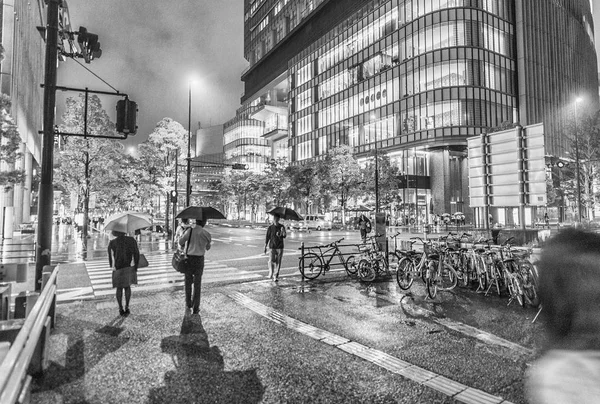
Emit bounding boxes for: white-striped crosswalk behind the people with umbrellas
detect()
[57,253,263,301]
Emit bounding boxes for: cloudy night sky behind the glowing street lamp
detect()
[56,0,248,145]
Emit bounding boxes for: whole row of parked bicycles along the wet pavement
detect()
[299,233,539,307]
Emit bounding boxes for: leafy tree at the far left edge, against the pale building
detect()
[0,94,25,189]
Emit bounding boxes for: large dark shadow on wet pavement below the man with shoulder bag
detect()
[148,315,265,404]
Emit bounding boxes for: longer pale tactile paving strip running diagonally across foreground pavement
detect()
[228,292,512,404]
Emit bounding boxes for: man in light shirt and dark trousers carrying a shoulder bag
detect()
[179,219,212,314]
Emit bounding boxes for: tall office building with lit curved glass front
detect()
[233,0,598,226]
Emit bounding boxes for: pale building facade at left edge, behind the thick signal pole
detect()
[0,1,45,238]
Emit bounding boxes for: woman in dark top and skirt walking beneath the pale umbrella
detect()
[108,231,140,316]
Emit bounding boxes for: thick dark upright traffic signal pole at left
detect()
[35,0,61,291]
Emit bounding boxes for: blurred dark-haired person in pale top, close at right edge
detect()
[526,229,600,404]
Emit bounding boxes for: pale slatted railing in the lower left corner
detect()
[0,266,59,404]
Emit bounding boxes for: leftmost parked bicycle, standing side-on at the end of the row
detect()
[298,238,358,279]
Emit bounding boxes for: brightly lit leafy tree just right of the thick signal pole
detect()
[56,94,123,237]
